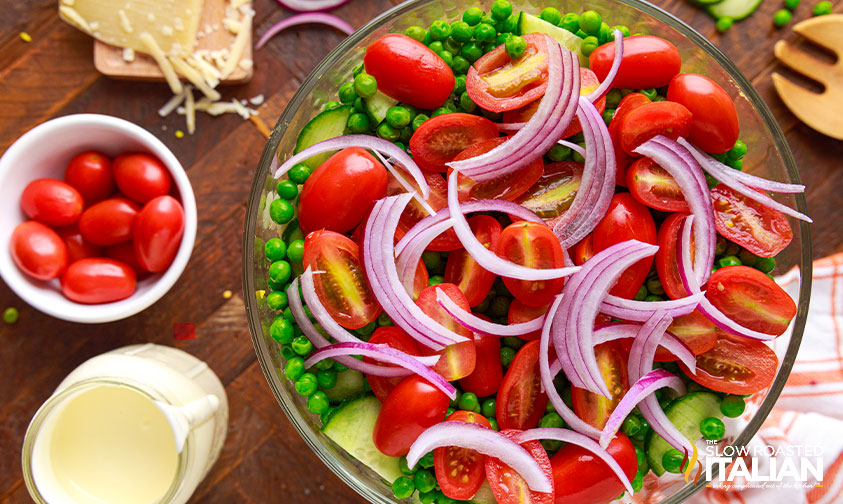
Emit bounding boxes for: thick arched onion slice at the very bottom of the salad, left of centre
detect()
[407,422,553,493]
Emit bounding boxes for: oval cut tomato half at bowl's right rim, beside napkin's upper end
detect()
[705,266,796,336]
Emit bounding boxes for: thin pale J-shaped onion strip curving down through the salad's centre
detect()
[448,169,579,281]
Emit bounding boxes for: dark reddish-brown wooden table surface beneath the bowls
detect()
[0,0,843,503]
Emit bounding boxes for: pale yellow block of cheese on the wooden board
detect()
[59,0,204,57]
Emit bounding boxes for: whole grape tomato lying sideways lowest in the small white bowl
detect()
[61,257,137,304]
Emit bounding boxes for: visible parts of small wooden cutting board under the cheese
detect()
[94,0,253,84]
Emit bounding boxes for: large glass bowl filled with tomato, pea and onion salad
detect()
[242,0,811,504]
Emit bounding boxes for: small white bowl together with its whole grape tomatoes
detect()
[0,114,197,323]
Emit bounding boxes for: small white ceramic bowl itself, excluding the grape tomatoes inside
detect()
[0,114,197,324]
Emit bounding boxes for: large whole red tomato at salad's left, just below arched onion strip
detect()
[298,147,388,233]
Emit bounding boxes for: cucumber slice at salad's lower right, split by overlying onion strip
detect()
[645,390,728,476]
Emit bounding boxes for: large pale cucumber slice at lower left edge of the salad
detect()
[322,396,401,483]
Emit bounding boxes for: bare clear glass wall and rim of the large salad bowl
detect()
[243,0,811,504]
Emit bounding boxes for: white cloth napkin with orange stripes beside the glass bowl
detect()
[630,253,843,504]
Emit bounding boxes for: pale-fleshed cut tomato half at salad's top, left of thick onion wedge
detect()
[466,33,548,112]
